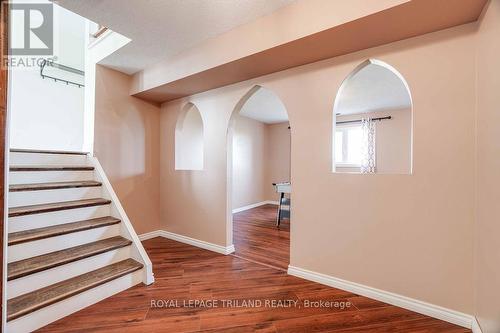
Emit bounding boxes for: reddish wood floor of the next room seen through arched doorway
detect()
[233,205,290,270]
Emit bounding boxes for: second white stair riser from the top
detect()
[9,170,94,184]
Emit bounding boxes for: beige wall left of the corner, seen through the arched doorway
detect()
[232,115,267,209]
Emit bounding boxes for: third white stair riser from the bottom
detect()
[7,224,120,263]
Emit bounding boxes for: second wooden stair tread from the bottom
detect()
[7,236,132,281]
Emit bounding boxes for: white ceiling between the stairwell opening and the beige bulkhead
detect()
[56,0,295,74]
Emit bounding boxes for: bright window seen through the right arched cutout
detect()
[335,124,363,167]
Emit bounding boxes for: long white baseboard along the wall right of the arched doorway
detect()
[288,265,475,329]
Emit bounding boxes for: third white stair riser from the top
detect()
[9,186,102,207]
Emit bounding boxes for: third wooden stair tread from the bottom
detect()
[9,216,120,245]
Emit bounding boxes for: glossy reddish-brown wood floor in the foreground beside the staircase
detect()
[40,238,470,333]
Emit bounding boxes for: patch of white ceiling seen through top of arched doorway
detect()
[240,88,288,124]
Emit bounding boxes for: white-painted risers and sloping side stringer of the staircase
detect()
[5,153,154,333]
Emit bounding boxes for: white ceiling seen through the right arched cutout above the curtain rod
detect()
[335,64,411,115]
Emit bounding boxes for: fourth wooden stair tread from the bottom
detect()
[9,198,111,217]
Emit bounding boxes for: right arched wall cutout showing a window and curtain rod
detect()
[332,59,412,174]
